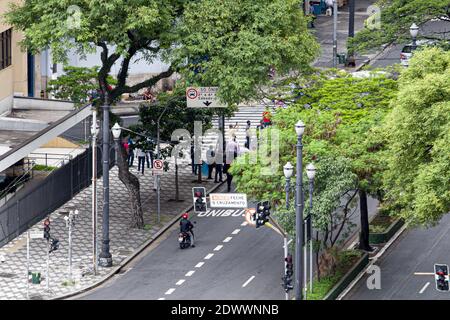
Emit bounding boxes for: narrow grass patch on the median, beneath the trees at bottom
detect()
[306,250,362,300]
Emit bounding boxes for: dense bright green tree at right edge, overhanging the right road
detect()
[384,48,450,226]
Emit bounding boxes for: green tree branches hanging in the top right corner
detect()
[350,0,450,52]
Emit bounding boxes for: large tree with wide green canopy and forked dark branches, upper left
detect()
[6,0,318,228]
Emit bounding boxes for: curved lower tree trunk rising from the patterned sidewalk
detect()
[116,139,144,229]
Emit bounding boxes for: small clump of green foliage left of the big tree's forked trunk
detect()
[47,66,117,107]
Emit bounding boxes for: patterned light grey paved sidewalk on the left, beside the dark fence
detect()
[0,159,219,300]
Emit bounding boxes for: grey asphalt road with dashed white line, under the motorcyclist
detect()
[75,184,285,300]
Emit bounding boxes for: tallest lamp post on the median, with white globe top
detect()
[295,120,305,300]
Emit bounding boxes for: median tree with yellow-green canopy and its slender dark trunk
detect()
[232,72,397,250]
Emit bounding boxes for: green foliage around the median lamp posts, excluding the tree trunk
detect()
[231,72,397,246]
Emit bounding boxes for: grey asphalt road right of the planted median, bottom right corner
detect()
[344,215,450,300]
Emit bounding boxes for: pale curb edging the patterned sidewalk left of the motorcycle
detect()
[49,181,225,300]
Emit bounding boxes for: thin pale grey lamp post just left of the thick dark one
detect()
[91,109,99,275]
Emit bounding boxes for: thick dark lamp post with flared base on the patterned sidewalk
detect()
[99,103,112,268]
